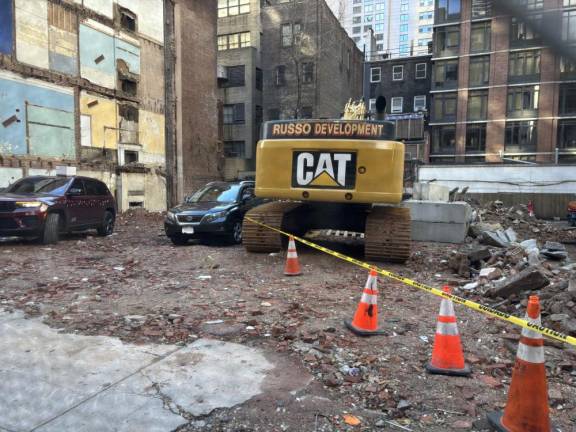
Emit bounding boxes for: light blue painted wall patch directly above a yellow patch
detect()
[80,24,116,89]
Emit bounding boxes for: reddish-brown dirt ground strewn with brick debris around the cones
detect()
[0,214,576,432]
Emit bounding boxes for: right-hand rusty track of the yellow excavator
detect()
[364,206,411,263]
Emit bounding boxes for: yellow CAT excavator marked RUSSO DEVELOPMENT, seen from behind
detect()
[243,102,411,262]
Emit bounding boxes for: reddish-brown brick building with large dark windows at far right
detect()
[430,0,576,163]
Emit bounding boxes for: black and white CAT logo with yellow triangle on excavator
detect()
[292,151,356,189]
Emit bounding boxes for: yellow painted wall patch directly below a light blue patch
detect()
[80,92,118,149]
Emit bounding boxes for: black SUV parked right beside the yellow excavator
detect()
[164,181,263,245]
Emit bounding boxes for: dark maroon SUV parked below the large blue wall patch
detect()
[0,176,116,244]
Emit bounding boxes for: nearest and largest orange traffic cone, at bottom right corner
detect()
[488,296,556,432]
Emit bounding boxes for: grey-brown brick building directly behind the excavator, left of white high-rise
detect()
[218,0,363,178]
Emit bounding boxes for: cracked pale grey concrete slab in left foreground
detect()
[0,311,274,432]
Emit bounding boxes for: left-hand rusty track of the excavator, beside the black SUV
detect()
[242,201,302,252]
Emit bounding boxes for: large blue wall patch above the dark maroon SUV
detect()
[0,74,76,159]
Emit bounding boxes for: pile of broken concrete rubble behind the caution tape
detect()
[446,201,576,335]
